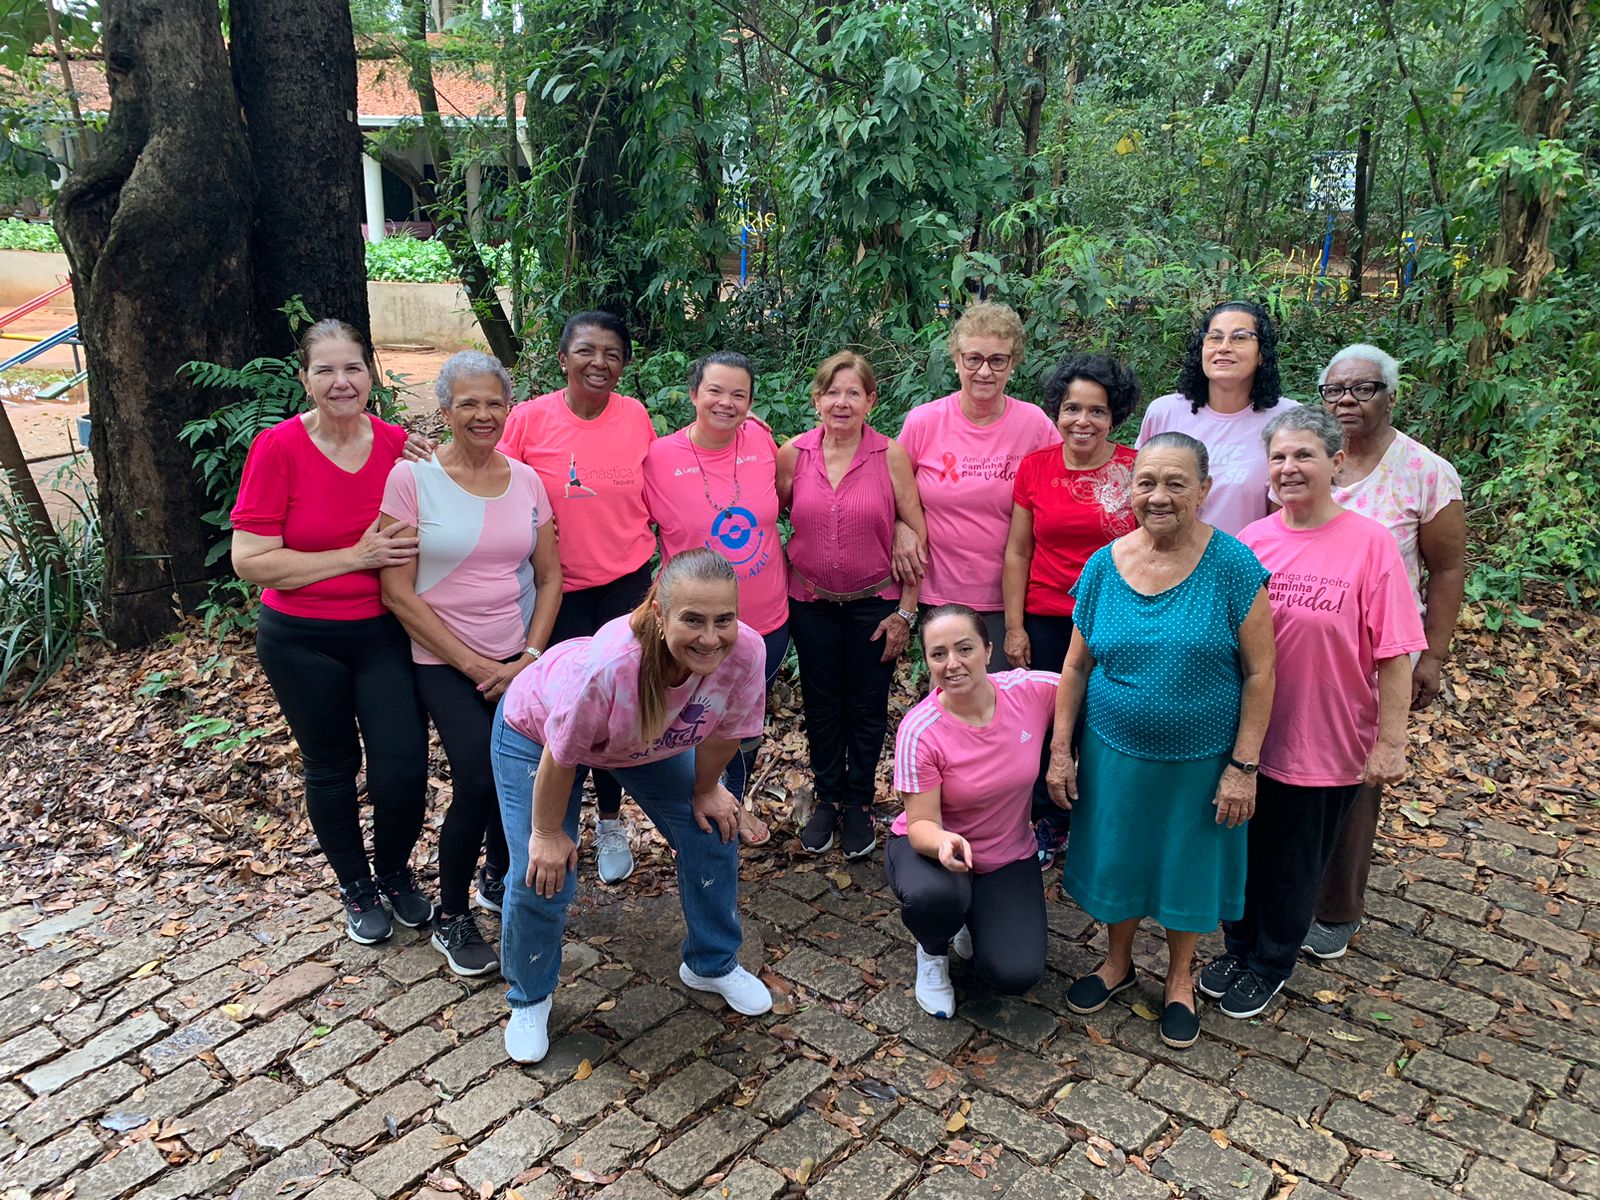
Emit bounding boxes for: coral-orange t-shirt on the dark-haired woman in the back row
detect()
[499,389,656,592]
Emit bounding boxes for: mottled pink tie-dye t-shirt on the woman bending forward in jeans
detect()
[504,616,766,770]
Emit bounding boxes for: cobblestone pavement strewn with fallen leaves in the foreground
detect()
[0,821,1600,1200]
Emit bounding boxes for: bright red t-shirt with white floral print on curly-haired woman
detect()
[1011,445,1136,616]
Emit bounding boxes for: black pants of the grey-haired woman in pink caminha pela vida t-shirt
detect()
[1222,774,1360,987]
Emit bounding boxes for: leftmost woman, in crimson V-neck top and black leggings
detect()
[232,320,434,944]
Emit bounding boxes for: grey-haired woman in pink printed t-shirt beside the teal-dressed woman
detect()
[1198,408,1427,1018]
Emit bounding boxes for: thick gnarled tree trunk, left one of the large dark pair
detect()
[56,0,254,645]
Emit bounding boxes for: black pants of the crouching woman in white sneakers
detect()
[883,837,1045,995]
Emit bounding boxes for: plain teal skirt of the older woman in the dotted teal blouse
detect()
[1061,728,1248,933]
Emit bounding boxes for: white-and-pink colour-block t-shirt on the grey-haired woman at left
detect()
[382,459,550,664]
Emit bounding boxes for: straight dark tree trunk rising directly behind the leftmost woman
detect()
[230,0,370,355]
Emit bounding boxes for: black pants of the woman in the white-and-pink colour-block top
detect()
[416,664,510,917]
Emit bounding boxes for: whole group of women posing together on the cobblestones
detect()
[234,302,1462,1061]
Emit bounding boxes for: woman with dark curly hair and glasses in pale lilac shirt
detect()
[1136,301,1294,538]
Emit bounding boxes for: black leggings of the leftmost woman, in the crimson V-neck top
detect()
[256,605,427,885]
